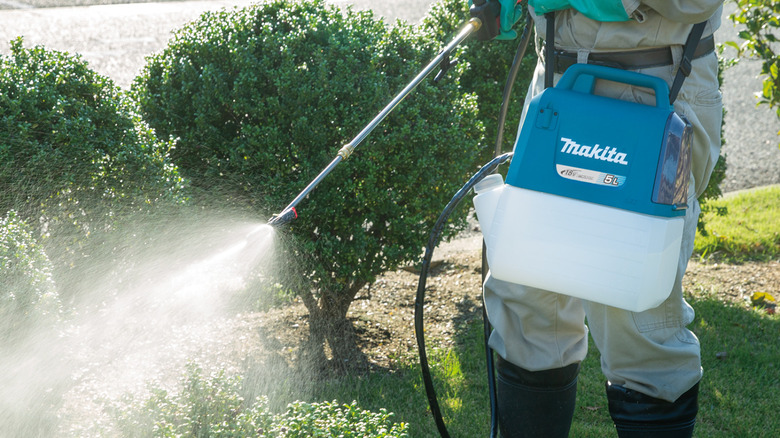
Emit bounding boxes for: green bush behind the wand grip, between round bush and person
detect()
[420,0,536,162]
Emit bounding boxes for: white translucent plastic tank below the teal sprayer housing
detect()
[474,175,683,312]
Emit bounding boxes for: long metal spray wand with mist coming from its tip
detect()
[268,18,482,227]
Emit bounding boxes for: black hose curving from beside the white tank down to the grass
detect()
[414,152,512,438]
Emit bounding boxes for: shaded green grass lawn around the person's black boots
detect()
[315,293,780,438]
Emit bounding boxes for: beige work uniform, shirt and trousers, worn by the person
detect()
[484,0,722,401]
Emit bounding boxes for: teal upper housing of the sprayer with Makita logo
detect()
[506,64,690,217]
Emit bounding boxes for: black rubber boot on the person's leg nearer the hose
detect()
[497,357,580,438]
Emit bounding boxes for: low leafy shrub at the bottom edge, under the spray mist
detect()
[115,365,407,438]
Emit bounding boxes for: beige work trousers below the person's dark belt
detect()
[484,49,722,401]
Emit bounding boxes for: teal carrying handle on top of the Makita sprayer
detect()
[555,64,671,109]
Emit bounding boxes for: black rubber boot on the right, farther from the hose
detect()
[607,382,699,438]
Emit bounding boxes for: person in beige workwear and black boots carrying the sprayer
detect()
[482,0,723,438]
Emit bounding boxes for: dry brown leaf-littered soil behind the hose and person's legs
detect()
[263,243,780,369]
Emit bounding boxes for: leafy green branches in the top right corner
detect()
[724,0,780,145]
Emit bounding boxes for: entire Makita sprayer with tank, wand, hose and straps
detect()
[268,0,703,437]
